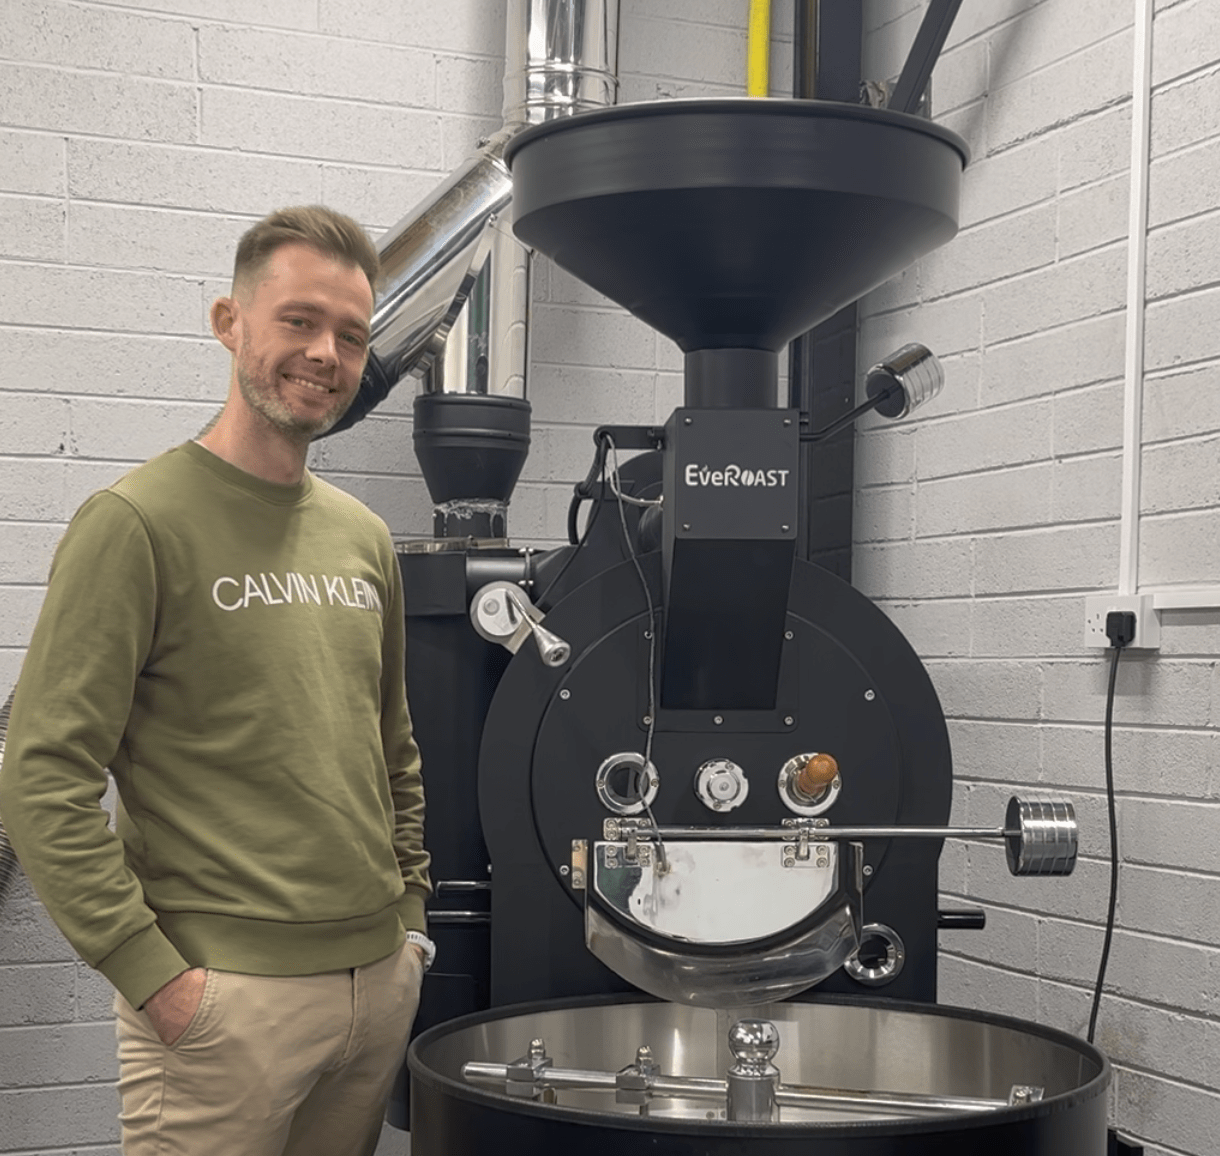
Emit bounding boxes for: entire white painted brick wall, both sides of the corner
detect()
[0,0,1220,1156]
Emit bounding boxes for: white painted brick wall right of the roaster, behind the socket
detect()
[855,0,1220,1156]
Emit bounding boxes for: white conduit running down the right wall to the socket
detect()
[1118,0,1220,610]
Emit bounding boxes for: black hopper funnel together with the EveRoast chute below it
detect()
[506,100,966,712]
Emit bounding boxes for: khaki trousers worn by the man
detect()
[115,944,422,1156]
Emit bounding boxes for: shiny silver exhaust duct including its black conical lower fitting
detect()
[356,0,619,538]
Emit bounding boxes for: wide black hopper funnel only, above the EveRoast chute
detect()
[508,99,967,380]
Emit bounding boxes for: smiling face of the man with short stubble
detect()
[231,243,373,440]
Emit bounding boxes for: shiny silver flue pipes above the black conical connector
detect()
[373,0,619,398]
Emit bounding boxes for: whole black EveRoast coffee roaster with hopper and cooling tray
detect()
[392,100,1109,1156]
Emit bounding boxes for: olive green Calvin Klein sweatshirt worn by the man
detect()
[0,443,428,1007]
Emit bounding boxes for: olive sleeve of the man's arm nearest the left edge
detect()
[0,491,189,1007]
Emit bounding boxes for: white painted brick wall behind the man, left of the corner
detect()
[0,0,761,1156]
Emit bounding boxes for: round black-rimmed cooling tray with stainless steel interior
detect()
[409,997,1110,1156]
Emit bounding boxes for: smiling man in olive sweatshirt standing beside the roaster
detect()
[0,206,431,1156]
